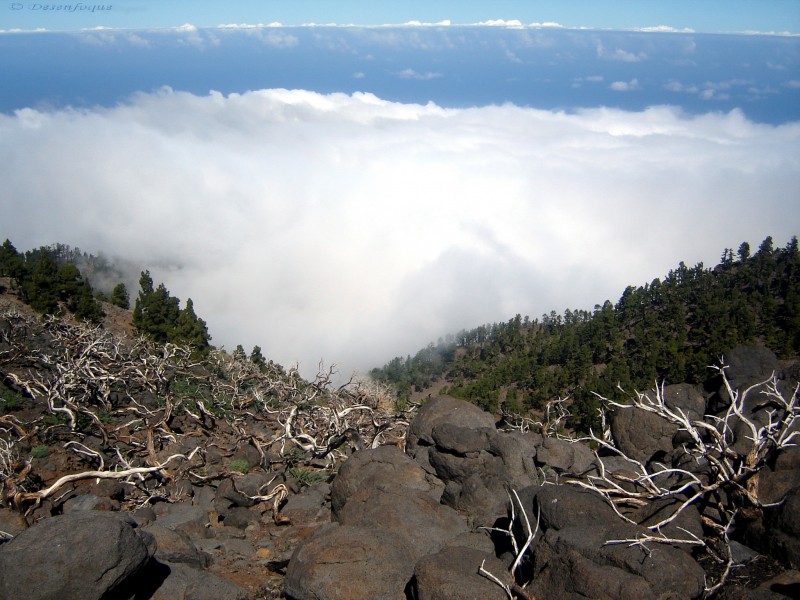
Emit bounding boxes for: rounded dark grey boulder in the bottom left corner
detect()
[0,511,156,600]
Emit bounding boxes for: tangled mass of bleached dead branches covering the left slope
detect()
[0,312,408,522]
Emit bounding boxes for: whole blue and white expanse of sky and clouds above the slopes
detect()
[0,0,800,376]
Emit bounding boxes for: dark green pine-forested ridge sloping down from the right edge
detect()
[370,236,800,431]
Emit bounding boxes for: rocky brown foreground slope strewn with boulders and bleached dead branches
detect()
[0,298,800,600]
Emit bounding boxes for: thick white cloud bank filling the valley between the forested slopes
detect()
[0,89,800,374]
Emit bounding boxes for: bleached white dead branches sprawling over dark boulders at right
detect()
[569,366,800,593]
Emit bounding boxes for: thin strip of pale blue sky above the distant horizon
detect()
[0,0,800,33]
